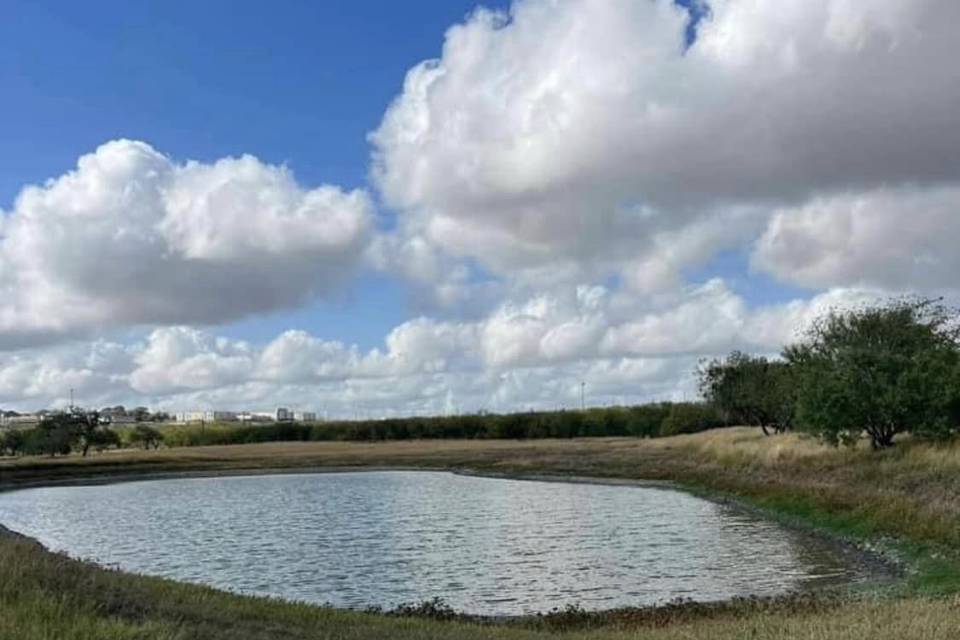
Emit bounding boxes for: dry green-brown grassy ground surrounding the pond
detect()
[0,429,960,640]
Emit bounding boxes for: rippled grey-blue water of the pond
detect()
[0,471,867,615]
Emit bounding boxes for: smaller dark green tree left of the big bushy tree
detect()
[697,351,796,435]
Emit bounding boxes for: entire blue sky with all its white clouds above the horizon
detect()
[0,0,960,417]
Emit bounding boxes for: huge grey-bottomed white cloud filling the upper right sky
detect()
[371,0,960,290]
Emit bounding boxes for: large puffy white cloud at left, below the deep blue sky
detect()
[0,140,372,347]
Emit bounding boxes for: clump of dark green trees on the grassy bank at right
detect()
[699,299,960,449]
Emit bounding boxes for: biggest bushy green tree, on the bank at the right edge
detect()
[784,300,960,449]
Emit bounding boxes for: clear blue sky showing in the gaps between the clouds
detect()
[0,0,720,356]
